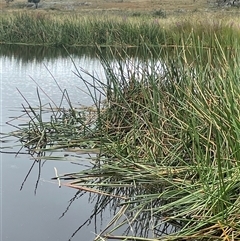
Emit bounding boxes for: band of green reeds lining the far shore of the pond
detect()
[0,11,240,47]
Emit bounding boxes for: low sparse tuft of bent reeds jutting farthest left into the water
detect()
[8,74,105,155]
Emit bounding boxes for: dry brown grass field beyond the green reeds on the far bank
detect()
[0,0,213,12]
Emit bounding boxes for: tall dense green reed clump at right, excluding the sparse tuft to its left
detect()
[61,38,240,240]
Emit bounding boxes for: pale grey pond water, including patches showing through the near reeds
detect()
[0,46,178,241]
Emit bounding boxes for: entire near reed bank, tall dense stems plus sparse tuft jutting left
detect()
[7,31,240,240]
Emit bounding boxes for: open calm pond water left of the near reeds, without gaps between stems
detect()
[0,46,108,241]
